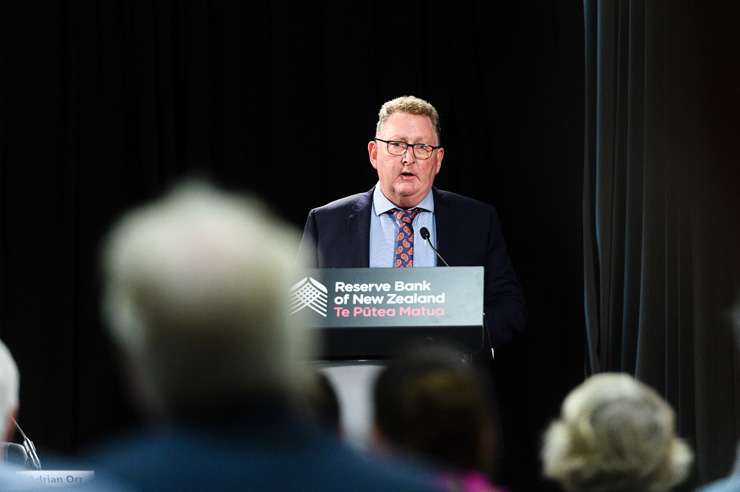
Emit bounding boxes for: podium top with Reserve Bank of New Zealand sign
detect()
[290,267,483,358]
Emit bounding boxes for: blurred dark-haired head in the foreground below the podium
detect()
[373,347,494,473]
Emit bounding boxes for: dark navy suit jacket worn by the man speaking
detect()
[301,188,525,347]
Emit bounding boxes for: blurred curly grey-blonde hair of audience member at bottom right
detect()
[542,373,692,492]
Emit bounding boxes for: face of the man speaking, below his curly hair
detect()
[367,113,444,208]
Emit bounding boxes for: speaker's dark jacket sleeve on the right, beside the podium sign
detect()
[484,209,526,347]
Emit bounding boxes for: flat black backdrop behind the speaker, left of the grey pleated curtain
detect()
[0,0,585,490]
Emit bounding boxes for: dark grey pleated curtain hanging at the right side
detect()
[584,0,740,490]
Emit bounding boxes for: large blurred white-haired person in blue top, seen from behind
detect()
[92,185,437,492]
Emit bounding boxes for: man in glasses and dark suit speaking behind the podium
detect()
[301,96,525,347]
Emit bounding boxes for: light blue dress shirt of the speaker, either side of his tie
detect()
[370,183,437,268]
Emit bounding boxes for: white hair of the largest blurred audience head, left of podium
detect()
[103,182,312,410]
